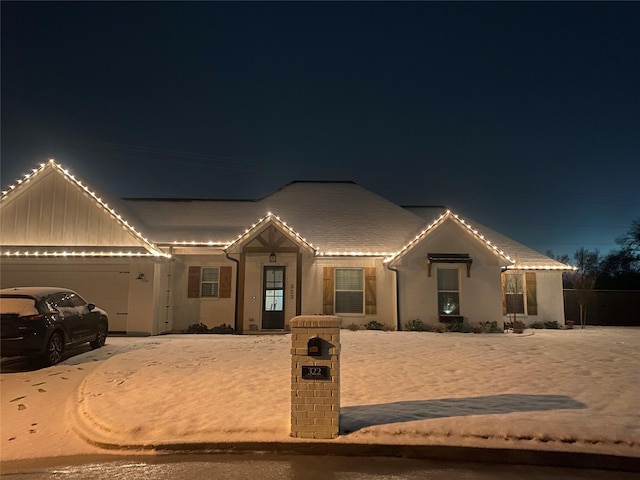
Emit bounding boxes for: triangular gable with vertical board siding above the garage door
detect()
[0,160,166,257]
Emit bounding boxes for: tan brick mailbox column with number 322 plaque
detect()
[289,315,340,439]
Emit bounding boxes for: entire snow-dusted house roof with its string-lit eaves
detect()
[2,160,572,270]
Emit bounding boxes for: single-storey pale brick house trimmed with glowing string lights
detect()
[0,160,571,335]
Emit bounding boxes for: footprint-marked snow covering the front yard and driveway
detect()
[0,327,640,461]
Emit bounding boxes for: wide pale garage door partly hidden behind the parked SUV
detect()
[1,263,129,333]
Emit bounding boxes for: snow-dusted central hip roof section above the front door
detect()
[122,182,424,256]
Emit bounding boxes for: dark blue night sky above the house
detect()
[1,1,640,255]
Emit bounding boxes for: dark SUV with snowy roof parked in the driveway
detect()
[0,287,109,365]
